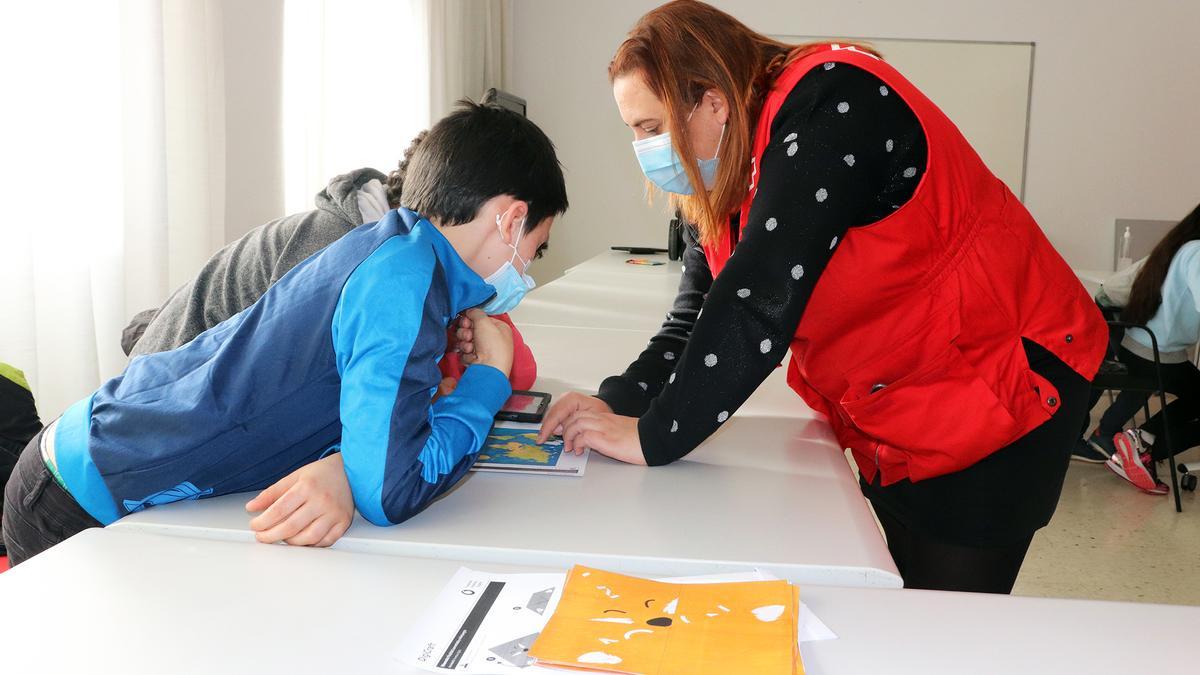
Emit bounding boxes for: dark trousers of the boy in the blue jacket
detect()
[4,432,102,565]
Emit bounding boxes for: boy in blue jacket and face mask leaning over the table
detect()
[4,102,568,565]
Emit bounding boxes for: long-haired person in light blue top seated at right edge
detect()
[1088,201,1200,495]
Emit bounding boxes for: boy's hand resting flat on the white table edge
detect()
[246,453,354,546]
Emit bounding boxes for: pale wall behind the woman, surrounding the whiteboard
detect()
[511,0,1200,280]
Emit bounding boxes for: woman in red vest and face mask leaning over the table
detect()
[542,0,1106,592]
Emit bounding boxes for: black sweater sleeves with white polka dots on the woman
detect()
[625,62,925,464]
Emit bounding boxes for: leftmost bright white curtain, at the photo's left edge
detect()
[0,0,224,419]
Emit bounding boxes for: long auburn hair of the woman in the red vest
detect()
[608,0,878,244]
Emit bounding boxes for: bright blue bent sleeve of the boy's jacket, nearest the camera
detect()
[332,239,512,526]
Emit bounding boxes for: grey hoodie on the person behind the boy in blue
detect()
[129,168,386,357]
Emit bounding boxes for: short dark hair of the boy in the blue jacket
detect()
[398,100,568,229]
